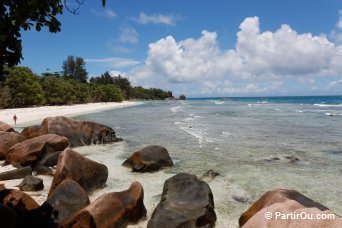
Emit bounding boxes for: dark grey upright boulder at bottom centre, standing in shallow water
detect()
[147,173,216,228]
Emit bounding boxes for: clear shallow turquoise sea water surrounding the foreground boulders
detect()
[76,96,342,227]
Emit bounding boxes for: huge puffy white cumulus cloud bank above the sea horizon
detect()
[130,17,342,93]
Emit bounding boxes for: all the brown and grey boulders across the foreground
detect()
[0,117,342,228]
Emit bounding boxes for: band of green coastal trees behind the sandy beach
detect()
[0,56,172,108]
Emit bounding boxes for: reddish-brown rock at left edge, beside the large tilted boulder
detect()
[0,131,26,159]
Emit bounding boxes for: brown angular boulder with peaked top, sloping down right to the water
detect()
[49,148,108,195]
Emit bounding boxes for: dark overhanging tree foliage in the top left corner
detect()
[0,0,63,78]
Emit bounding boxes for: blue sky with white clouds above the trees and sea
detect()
[21,0,342,97]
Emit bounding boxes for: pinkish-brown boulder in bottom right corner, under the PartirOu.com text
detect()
[239,189,342,228]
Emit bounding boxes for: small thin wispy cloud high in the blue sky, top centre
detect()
[133,12,176,25]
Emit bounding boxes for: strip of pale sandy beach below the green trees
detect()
[0,101,141,128]
